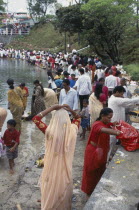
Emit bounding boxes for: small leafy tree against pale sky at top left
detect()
[27,0,57,18]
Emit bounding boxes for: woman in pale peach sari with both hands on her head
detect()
[33,105,80,210]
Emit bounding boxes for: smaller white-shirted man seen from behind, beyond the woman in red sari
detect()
[105,70,117,96]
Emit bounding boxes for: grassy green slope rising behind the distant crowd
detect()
[6,23,87,52]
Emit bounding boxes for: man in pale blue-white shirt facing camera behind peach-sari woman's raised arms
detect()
[59,79,78,110]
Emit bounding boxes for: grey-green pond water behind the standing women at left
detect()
[0,59,48,110]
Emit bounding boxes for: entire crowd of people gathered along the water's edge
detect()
[0,49,139,210]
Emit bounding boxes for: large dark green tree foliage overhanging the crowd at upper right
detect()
[56,0,139,62]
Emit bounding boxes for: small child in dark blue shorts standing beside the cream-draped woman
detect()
[80,99,90,140]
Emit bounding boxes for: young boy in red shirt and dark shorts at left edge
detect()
[2,119,20,174]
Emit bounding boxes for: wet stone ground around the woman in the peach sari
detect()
[0,115,86,210]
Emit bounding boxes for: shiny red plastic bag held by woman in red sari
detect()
[116,120,139,151]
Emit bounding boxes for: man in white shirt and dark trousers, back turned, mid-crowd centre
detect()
[75,68,92,110]
